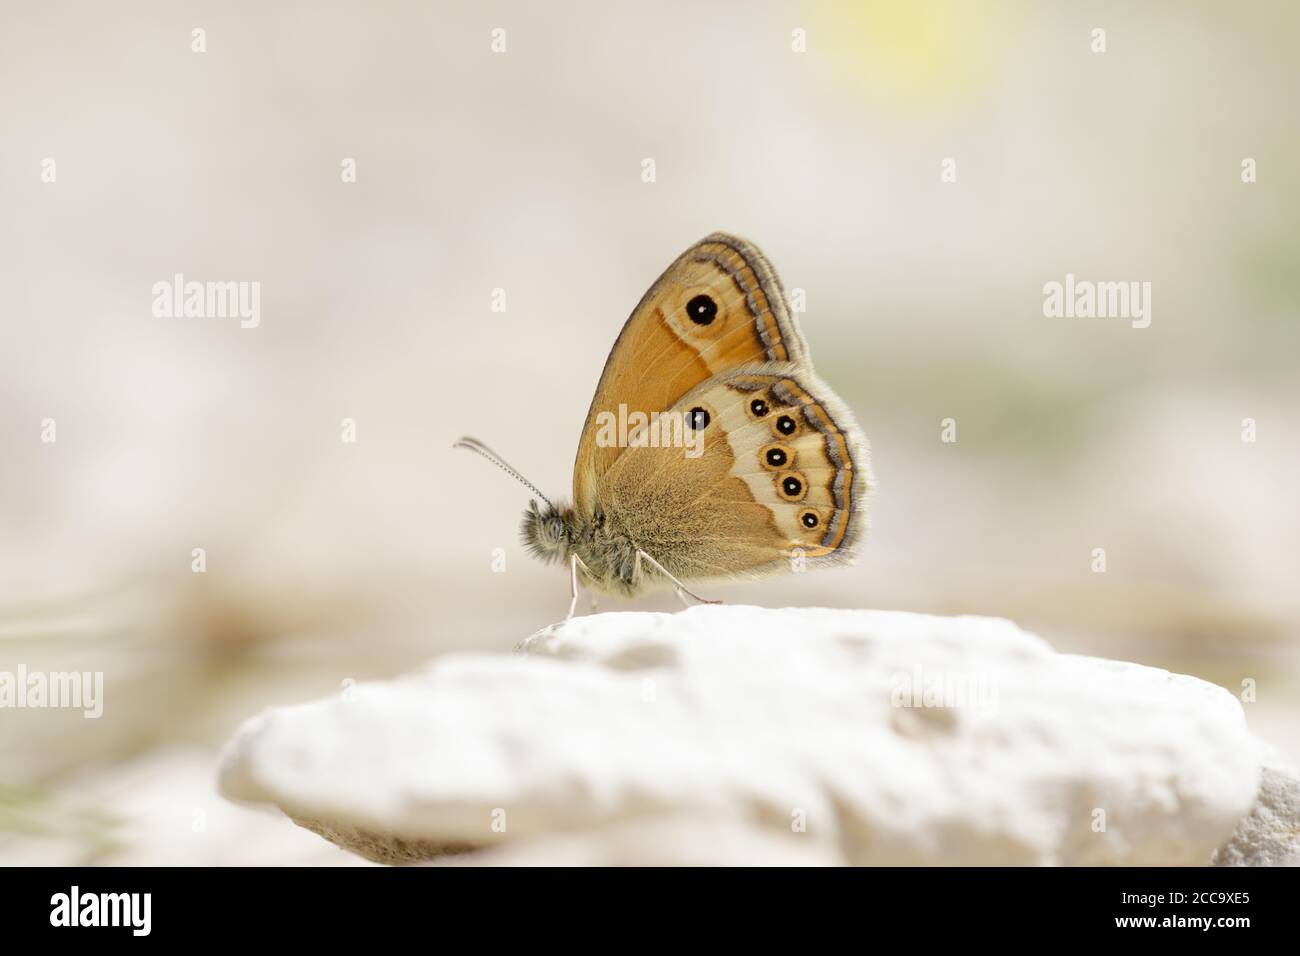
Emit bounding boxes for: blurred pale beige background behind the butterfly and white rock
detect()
[0,0,1300,864]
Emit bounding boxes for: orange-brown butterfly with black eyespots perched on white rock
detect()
[456,233,871,617]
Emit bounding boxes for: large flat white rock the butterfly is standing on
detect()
[221,606,1260,865]
